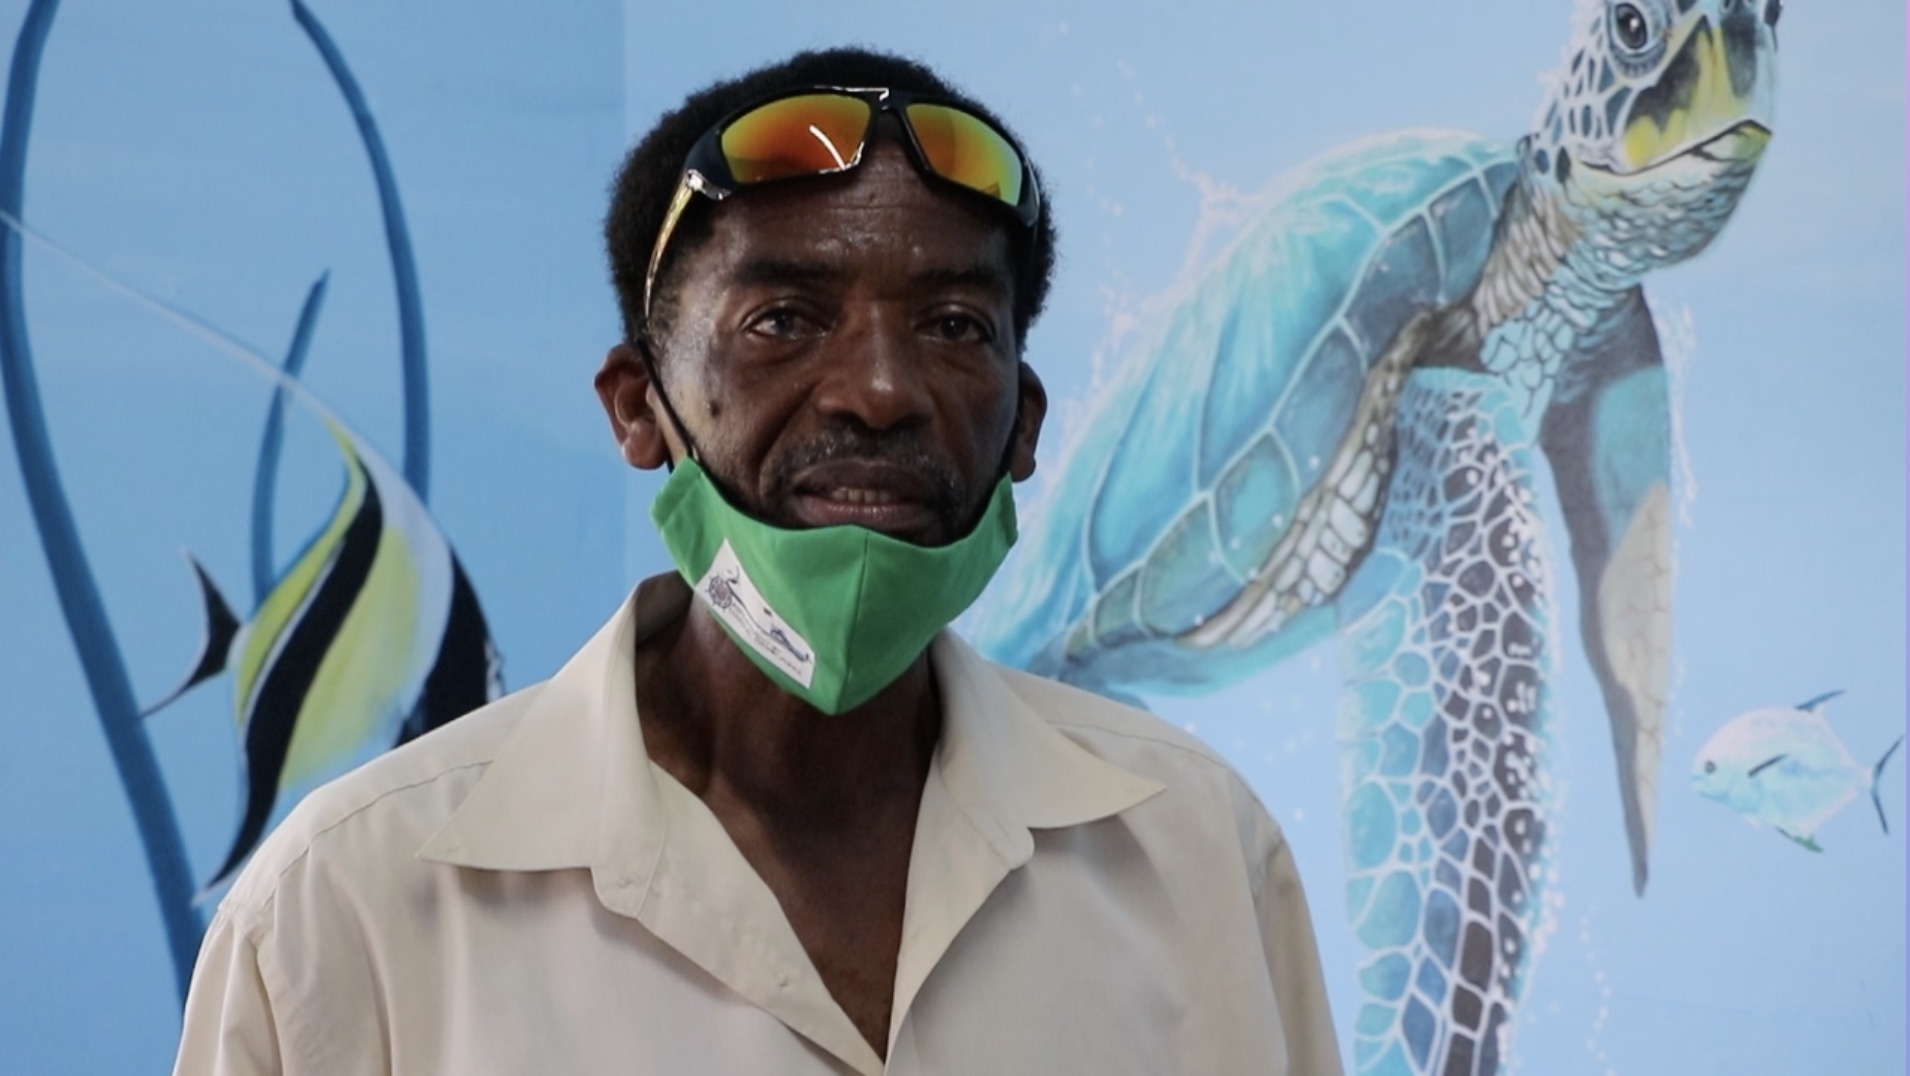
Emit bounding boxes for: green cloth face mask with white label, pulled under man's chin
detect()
[649,459,1014,713]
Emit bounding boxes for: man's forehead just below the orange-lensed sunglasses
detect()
[686,138,1014,292]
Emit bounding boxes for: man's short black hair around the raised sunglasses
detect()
[604,48,1054,344]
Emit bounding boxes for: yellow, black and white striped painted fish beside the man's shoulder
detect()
[145,419,502,891]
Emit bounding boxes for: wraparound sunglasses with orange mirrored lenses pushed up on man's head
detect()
[644,86,1041,325]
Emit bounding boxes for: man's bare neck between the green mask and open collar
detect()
[636,602,942,828]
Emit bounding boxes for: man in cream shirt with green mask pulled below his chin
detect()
[180,50,1339,1076]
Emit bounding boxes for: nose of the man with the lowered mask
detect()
[816,308,930,430]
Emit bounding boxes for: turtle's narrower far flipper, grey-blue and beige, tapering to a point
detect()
[1541,289,1673,893]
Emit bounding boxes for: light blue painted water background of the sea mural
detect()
[0,0,1910,1074]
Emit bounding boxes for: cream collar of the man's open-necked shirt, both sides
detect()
[418,573,1161,886]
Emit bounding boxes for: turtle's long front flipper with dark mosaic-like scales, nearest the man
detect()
[1339,369,1553,1076]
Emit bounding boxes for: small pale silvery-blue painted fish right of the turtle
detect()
[1690,692,1904,852]
